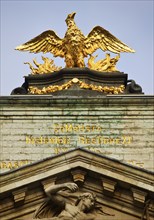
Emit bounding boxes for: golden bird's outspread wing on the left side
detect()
[15,30,65,57]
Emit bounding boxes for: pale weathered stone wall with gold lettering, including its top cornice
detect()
[0,95,154,172]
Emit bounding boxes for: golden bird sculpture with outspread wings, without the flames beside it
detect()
[16,12,135,68]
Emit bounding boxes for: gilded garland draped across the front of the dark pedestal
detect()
[28,78,125,95]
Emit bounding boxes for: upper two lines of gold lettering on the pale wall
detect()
[26,123,133,146]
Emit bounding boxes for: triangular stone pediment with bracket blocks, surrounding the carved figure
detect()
[0,148,154,220]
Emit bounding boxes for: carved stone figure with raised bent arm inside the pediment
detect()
[33,183,113,220]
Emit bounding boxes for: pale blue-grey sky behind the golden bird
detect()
[0,0,154,96]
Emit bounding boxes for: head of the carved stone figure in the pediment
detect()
[76,192,96,212]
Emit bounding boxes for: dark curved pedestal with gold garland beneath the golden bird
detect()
[11,67,143,94]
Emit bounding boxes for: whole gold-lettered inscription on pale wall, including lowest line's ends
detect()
[0,123,137,170]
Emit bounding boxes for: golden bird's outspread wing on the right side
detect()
[84,26,135,55]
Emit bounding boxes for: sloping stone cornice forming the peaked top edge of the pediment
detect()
[0,149,154,193]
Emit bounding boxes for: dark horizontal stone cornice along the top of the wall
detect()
[0,95,154,107]
